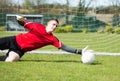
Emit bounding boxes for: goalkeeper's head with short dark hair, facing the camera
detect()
[46,20,58,33]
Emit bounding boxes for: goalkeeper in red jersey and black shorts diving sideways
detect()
[0,15,87,62]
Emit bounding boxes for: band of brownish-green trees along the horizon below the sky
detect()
[0,0,120,15]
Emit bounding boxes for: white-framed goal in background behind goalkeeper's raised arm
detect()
[6,14,43,31]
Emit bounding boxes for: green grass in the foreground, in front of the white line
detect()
[0,54,120,81]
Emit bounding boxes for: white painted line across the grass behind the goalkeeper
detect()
[0,50,120,56]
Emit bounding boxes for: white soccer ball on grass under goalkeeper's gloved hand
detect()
[81,50,95,64]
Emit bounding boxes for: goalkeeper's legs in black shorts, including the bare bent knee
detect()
[0,36,24,62]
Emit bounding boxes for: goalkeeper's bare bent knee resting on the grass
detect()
[5,51,20,62]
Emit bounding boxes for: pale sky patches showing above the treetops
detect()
[12,0,110,7]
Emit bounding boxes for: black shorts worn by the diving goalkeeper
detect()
[0,36,24,57]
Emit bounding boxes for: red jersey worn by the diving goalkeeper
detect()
[16,21,63,52]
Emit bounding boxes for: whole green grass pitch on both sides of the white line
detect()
[0,32,120,81]
